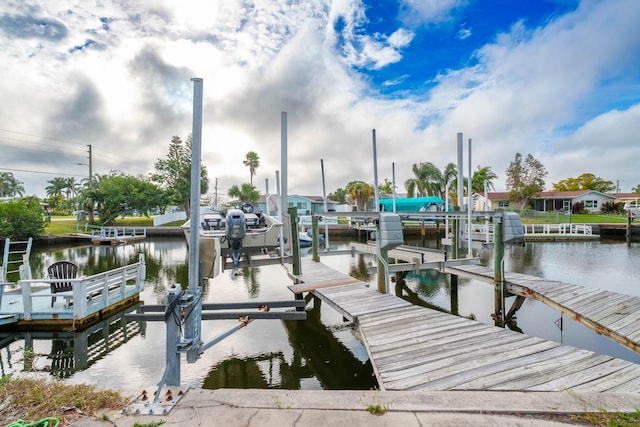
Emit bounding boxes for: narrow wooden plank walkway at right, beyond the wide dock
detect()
[444,265,640,352]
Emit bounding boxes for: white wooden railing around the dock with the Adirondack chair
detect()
[18,254,146,320]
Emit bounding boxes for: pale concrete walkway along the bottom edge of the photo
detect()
[71,389,640,427]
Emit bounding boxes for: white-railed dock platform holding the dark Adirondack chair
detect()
[0,254,146,330]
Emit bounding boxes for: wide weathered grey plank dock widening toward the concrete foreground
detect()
[289,260,640,394]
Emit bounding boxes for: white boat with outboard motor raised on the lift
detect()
[182,202,282,277]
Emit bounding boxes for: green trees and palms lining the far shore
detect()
[0,144,640,241]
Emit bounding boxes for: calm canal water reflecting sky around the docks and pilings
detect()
[0,238,640,391]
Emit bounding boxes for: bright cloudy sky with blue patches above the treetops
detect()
[0,0,640,201]
